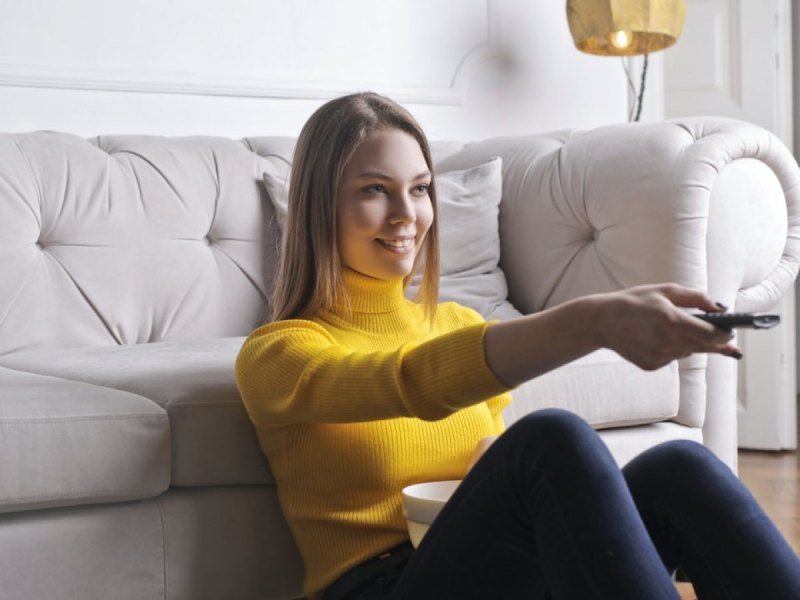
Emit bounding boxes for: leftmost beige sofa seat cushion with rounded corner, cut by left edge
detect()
[0,367,170,513]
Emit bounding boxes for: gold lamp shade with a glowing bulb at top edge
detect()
[567,0,686,56]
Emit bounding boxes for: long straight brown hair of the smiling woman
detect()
[272,92,439,321]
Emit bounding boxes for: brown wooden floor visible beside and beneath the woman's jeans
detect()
[678,451,800,600]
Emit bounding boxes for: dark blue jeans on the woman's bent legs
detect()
[382,410,800,600]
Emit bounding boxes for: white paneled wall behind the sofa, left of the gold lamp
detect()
[0,0,628,139]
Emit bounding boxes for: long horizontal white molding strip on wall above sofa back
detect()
[0,62,463,106]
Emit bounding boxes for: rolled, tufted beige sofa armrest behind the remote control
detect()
[440,118,800,472]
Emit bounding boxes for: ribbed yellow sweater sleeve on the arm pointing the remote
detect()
[236,320,508,425]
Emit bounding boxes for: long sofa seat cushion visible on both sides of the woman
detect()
[0,337,678,486]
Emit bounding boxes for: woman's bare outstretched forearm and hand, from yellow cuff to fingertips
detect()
[484,284,741,387]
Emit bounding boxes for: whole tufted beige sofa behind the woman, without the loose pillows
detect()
[0,119,800,600]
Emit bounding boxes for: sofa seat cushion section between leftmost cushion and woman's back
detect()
[0,337,274,486]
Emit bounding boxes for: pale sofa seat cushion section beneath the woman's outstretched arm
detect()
[503,349,680,429]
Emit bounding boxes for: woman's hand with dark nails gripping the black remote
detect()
[595,284,742,370]
